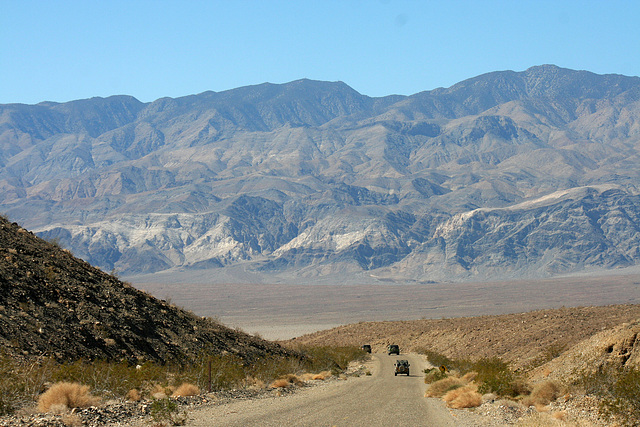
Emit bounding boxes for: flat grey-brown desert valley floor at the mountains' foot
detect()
[134,272,640,340]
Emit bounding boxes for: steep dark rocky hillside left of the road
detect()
[0,218,296,362]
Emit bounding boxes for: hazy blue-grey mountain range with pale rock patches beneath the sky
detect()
[0,65,640,283]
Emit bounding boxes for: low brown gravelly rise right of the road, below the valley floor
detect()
[291,305,640,369]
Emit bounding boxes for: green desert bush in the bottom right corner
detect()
[576,367,640,426]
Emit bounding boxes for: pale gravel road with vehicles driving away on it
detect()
[188,353,459,427]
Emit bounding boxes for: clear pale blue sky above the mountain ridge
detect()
[0,0,640,104]
